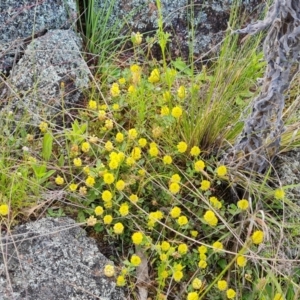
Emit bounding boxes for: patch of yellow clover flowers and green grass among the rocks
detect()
[0,1,300,300]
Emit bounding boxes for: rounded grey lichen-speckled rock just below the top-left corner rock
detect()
[5,30,89,126]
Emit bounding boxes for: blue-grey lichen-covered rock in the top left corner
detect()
[0,0,77,76]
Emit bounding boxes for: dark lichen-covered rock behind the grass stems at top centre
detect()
[96,0,263,58]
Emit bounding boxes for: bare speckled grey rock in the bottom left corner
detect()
[0,217,125,300]
